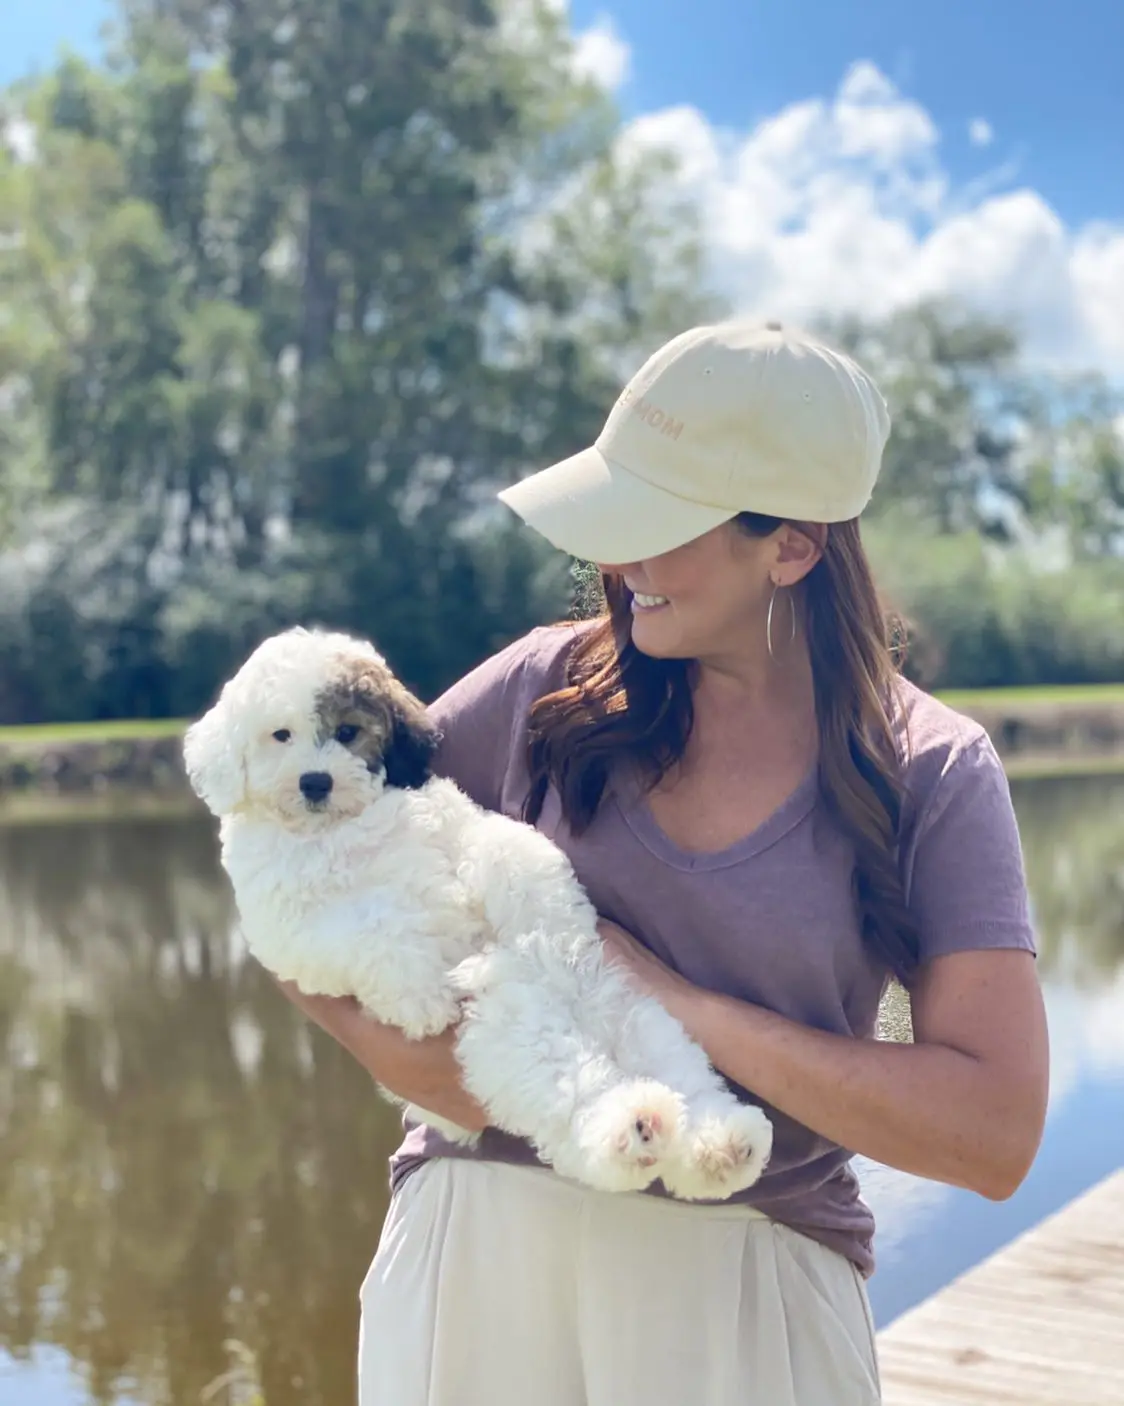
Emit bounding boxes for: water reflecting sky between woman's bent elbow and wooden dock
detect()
[858,778,1124,1324]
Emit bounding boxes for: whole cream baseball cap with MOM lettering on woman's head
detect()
[499,321,890,564]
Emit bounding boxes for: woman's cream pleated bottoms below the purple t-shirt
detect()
[359,1159,881,1406]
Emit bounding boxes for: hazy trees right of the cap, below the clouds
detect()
[831,304,1124,545]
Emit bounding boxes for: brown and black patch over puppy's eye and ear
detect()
[315,658,440,789]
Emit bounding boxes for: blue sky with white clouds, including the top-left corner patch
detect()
[0,0,1124,375]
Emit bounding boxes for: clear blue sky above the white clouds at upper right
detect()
[571,0,1124,221]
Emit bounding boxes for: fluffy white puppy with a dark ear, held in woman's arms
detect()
[184,628,772,1199]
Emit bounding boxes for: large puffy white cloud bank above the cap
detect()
[623,62,1124,375]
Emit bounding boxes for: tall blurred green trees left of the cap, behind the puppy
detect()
[0,0,712,716]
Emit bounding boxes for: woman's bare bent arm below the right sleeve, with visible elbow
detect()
[601,922,1049,1201]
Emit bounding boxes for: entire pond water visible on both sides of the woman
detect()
[0,778,1124,1406]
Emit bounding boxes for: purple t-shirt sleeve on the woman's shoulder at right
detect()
[909,733,1035,962]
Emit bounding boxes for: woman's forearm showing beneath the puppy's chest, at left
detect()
[277,981,488,1132]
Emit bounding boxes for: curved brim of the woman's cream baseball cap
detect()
[499,447,736,564]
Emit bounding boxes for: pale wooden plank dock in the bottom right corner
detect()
[878,1170,1124,1406]
